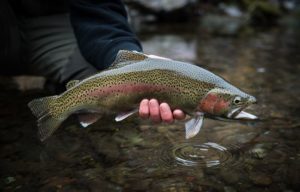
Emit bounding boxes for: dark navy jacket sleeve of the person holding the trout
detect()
[70,0,142,69]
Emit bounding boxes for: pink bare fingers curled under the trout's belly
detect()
[139,99,185,123]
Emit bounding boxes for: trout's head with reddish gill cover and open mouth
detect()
[197,88,257,119]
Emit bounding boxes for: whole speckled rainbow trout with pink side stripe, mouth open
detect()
[28,50,257,141]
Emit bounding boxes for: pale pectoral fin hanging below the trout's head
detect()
[185,112,204,139]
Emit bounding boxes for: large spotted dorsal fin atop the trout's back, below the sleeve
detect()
[111,50,148,67]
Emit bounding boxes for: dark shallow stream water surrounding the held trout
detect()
[0,26,300,192]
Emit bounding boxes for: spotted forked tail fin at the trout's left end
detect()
[28,96,65,141]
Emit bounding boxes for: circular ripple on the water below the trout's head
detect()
[159,142,242,168]
